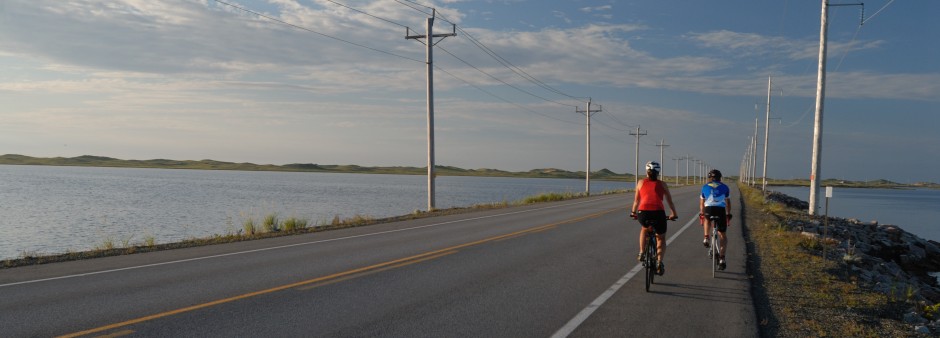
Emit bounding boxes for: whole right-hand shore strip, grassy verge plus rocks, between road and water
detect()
[739,184,940,337]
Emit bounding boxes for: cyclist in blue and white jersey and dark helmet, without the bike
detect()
[699,169,731,270]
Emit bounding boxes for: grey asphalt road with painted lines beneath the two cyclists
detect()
[0,188,757,337]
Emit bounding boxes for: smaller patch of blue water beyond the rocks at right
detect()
[770,187,940,242]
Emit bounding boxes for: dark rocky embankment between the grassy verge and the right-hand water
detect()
[768,192,940,335]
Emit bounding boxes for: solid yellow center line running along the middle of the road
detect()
[59,208,622,338]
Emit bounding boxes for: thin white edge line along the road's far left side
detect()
[0,198,620,288]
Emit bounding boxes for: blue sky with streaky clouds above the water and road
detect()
[0,0,940,183]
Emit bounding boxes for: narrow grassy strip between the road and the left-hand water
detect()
[0,190,629,269]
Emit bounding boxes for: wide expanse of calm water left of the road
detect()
[0,165,633,259]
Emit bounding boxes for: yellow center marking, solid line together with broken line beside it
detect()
[59,208,620,338]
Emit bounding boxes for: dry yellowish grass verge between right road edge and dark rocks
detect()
[739,184,917,337]
